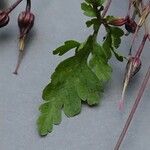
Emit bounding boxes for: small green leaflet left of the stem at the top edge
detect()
[81,3,96,17]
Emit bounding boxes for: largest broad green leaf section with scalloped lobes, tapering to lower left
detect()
[37,37,103,135]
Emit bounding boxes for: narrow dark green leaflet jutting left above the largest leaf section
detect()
[53,40,80,56]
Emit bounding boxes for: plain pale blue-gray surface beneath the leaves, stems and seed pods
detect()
[0,0,150,150]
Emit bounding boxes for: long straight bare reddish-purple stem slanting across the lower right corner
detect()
[114,66,150,150]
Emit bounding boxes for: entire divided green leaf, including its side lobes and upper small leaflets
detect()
[37,0,124,136]
